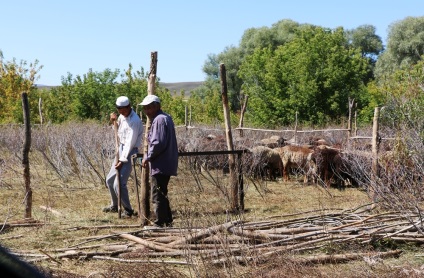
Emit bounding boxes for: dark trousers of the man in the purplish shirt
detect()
[152,174,173,226]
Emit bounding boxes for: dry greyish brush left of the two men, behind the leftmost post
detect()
[0,123,114,189]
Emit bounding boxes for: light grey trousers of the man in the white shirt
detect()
[106,144,138,210]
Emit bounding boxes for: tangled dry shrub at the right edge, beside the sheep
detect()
[344,126,424,212]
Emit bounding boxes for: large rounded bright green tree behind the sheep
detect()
[240,26,367,127]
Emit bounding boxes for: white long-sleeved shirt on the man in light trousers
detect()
[118,109,143,162]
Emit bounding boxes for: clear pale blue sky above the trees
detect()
[0,0,424,85]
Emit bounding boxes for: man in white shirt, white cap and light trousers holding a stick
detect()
[103,96,143,218]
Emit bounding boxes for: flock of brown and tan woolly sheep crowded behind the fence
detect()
[179,131,353,187]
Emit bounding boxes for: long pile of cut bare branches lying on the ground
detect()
[7,207,424,264]
